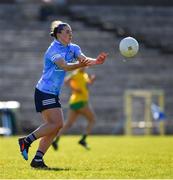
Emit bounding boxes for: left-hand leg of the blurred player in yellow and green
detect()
[52,109,79,150]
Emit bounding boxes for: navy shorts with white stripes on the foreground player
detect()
[34,88,61,112]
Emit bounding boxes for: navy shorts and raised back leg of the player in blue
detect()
[18,89,63,160]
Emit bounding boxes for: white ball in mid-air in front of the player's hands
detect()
[119,37,139,58]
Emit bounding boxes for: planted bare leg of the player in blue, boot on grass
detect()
[31,108,63,168]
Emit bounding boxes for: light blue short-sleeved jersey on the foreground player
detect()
[36,40,82,95]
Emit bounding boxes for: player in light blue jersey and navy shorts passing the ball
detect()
[18,21,107,168]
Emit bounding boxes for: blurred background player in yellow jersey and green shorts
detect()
[52,68,95,150]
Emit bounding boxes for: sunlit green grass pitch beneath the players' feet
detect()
[0,136,173,179]
